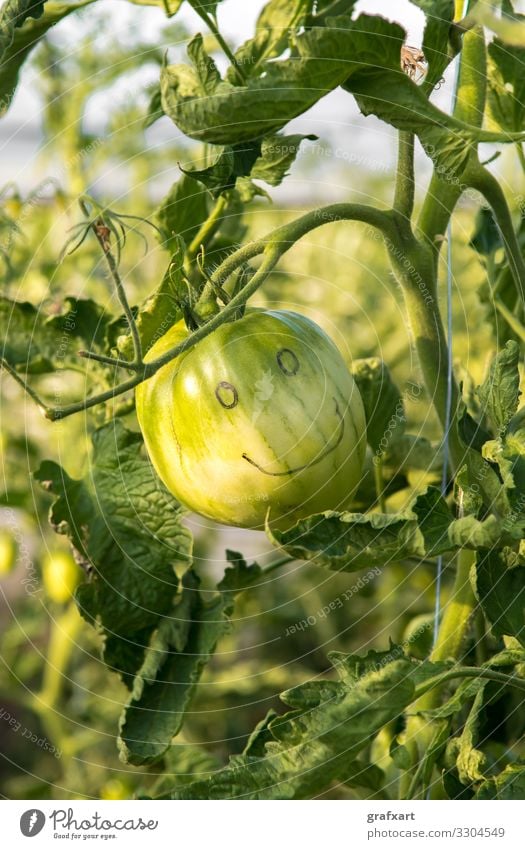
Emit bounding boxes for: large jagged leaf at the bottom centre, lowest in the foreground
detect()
[173,658,444,799]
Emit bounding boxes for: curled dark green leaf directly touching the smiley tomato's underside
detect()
[267,511,425,572]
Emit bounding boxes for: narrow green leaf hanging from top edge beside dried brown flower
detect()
[410,0,454,91]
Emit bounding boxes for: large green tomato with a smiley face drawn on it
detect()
[136,310,366,528]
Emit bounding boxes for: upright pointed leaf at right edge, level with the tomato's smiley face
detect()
[478,341,521,433]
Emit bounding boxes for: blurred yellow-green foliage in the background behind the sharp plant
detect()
[0,0,516,799]
